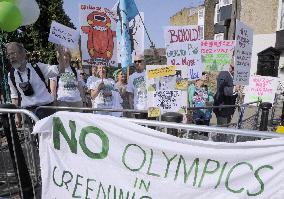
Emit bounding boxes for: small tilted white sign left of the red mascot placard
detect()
[48,21,80,48]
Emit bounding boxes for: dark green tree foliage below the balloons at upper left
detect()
[7,0,75,64]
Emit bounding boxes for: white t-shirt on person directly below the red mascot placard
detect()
[90,78,117,108]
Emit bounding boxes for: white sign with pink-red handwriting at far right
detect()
[244,75,278,103]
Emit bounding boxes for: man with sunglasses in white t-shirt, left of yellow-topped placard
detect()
[126,55,147,110]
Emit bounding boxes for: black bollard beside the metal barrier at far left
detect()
[0,104,34,199]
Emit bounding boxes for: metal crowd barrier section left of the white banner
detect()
[0,105,40,199]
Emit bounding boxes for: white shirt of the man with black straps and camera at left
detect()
[8,63,58,108]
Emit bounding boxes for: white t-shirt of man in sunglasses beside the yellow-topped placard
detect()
[126,71,147,110]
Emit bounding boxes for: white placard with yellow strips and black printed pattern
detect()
[146,66,189,115]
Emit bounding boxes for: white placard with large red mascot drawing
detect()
[80,4,117,66]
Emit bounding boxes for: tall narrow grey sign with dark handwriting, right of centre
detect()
[234,20,253,85]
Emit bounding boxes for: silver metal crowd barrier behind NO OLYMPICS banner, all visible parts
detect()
[0,107,284,199]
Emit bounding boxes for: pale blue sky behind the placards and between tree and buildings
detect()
[64,0,204,48]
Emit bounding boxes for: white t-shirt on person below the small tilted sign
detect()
[52,66,83,102]
